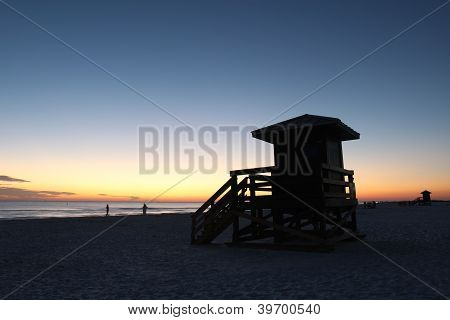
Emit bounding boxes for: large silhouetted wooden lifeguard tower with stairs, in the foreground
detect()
[191,114,359,248]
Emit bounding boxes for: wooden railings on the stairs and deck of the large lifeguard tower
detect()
[191,164,357,244]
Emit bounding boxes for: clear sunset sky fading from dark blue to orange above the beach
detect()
[0,0,450,201]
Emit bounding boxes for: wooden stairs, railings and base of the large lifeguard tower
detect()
[191,164,357,247]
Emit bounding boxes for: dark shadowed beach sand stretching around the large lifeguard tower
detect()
[0,205,450,299]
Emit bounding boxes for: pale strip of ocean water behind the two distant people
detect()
[0,201,201,219]
